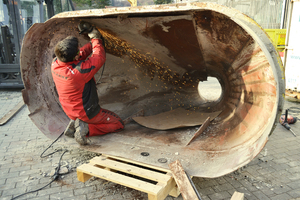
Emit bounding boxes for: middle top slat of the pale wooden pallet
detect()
[90,156,172,183]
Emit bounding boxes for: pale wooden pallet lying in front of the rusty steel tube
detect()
[77,155,180,200]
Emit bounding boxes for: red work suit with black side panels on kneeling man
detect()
[51,39,124,136]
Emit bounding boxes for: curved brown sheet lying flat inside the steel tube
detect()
[133,108,221,130]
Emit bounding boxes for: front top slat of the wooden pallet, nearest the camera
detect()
[77,164,161,195]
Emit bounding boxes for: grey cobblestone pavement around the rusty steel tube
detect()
[0,90,300,200]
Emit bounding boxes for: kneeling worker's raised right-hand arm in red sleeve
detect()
[76,39,106,82]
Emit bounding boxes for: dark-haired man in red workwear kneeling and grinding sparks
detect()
[51,27,124,145]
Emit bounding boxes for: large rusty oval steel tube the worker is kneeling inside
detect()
[21,3,284,177]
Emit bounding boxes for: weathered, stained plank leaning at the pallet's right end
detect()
[169,160,199,200]
